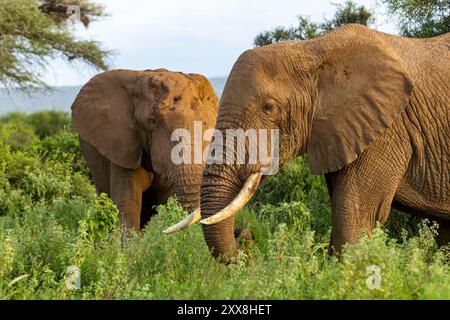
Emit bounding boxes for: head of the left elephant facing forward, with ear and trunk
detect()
[72,69,218,215]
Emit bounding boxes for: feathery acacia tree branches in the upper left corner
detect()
[0,0,109,89]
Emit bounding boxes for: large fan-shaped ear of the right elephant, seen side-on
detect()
[307,36,413,174]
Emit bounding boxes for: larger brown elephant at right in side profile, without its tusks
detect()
[201,25,450,261]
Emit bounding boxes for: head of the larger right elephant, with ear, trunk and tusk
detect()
[170,25,412,261]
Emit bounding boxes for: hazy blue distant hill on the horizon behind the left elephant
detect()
[0,77,226,114]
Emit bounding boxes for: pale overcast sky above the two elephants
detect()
[45,0,397,86]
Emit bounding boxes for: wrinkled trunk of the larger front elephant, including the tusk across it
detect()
[200,109,261,263]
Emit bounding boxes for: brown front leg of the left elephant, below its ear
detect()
[110,163,153,231]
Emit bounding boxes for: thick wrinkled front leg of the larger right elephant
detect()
[327,133,409,252]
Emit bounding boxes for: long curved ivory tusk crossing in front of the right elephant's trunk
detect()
[200,172,261,224]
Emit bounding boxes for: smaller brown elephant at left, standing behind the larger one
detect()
[72,69,218,230]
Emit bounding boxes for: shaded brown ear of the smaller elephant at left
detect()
[72,70,142,169]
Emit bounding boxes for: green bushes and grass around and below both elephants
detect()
[0,110,450,299]
